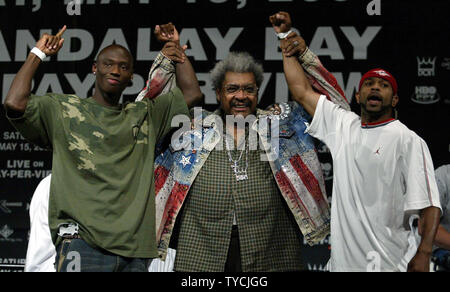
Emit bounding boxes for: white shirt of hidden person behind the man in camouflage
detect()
[25,175,176,272]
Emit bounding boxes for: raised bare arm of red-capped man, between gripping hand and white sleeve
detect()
[283,55,320,116]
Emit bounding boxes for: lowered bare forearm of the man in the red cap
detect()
[418,207,441,255]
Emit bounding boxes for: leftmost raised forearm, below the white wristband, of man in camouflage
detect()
[5,53,42,113]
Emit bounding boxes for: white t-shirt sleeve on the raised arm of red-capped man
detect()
[307,95,351,153]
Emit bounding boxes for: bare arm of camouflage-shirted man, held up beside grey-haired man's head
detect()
[176,57,203,108]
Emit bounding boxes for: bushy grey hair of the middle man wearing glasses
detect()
[210,52,264,90]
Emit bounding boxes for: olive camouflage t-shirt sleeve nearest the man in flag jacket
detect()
[149,87,190,141]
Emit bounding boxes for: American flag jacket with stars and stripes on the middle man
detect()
[138,49,350,260]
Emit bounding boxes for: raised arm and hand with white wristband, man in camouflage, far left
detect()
[5,26,66,117]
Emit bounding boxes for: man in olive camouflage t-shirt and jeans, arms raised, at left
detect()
[5,27,197,271]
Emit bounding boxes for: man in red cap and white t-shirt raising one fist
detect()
[272,13,441,272]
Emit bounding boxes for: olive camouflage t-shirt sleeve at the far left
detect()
[6,94,59,149]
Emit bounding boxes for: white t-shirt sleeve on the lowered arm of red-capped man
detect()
[401,135,442,211]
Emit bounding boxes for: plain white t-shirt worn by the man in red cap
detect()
[308,96,440,272]
